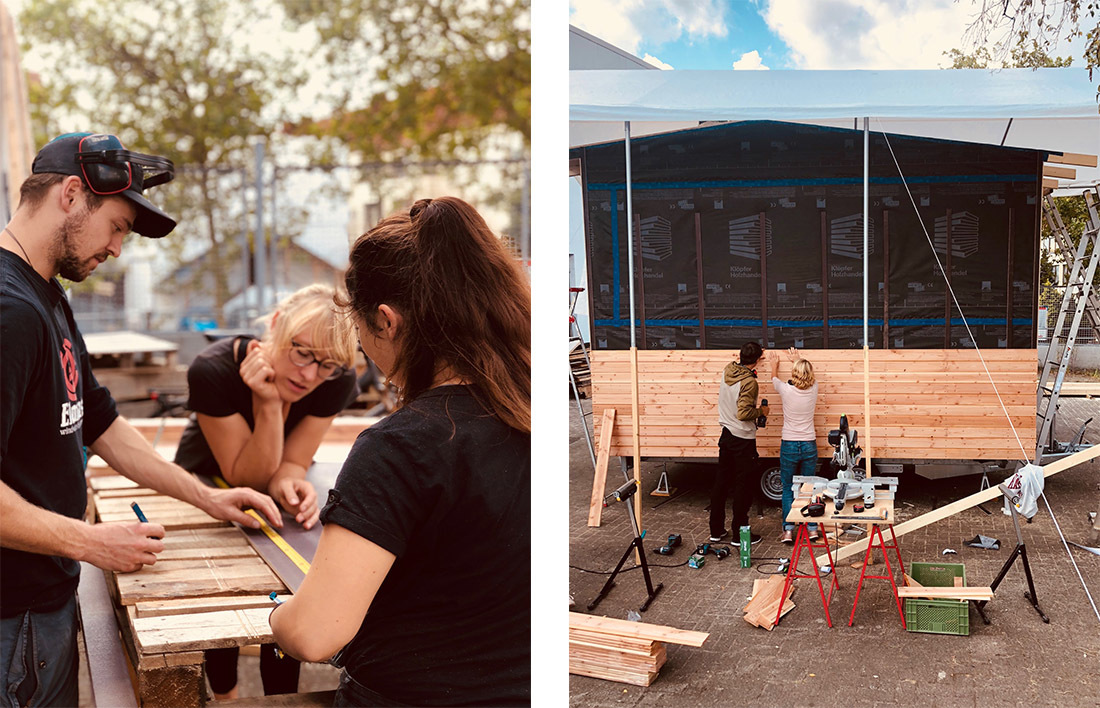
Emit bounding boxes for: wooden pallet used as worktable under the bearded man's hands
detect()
[88,474,288,707]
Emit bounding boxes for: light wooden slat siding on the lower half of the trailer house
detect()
[592,350,1036,460]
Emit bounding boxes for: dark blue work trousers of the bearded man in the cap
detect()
[0,594,79,708]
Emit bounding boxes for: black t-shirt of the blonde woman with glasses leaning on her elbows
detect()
[176,336,356,477]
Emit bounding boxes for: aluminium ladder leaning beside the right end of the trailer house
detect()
[1035,187,1100,465]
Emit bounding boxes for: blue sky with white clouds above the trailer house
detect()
[570,0,1084,69]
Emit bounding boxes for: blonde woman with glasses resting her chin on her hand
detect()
[176,285,356,700]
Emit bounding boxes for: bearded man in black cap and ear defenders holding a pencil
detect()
[0,133,282,706]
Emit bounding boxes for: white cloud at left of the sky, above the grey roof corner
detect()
[569,0,727,54]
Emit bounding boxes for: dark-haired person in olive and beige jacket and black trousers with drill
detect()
[711,342,769,543]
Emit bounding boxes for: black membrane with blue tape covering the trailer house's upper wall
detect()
[571,121,1045,349]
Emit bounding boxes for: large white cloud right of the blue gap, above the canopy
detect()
[761,0,975,69]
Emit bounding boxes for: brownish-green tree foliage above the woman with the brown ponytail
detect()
[279,0,531,162]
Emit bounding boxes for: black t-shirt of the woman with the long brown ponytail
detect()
[321,386,531,706]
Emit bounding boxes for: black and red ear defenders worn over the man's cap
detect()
[76,135,175,196]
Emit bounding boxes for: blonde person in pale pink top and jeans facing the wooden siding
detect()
[771,346,818,543]
